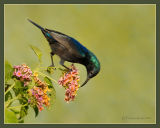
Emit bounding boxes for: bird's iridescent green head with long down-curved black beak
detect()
[81,53,100,87]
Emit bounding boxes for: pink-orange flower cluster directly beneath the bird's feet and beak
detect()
[58,64,80,102]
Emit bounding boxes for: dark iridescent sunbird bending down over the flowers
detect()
[28,19,100,87]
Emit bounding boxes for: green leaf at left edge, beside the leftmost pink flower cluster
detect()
[5,61,13,82]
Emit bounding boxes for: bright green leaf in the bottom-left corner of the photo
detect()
[5,109,18,123]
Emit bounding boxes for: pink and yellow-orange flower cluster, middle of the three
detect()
[29,73,50,111]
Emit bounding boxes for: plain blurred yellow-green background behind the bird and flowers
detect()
[5,5,155,123]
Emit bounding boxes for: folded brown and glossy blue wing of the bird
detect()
[46,29,87,58]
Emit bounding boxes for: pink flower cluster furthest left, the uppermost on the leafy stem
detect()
[13,64,33,86]
